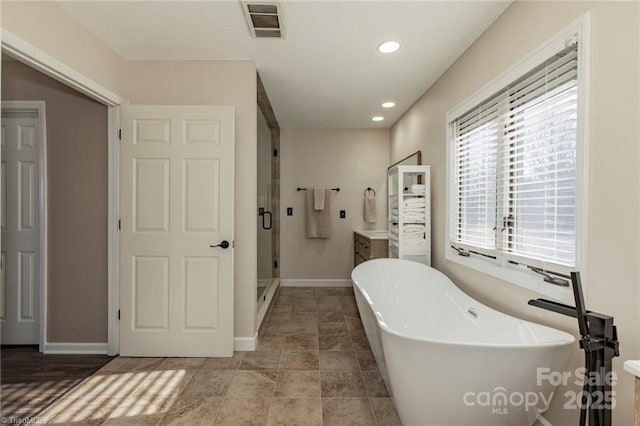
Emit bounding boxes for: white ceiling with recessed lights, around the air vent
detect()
[60,0,510,128]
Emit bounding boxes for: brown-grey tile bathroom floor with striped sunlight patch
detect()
[36,287,400,426]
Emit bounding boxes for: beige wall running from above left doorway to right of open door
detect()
[1,2,256,341]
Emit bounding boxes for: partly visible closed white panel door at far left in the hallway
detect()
[0,112,41,344]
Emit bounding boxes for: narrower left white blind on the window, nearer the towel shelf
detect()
[451,94,506,250]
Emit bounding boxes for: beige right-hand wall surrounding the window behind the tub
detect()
[391,2,640,425]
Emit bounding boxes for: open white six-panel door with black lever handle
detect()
[120,106,234,357]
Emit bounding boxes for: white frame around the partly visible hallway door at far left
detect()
[1,101,48,352]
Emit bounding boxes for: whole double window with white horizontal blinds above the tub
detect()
[449,44,579,274]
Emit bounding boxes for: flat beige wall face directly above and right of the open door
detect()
[126,61,257,337]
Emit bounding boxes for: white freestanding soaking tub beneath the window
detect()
[351,259,575,426]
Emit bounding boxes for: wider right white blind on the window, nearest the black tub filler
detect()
[498,45,578,269]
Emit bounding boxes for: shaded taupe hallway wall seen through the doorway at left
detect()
[2,61,107,343]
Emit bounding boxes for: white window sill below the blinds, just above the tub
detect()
[446,247,584,306]
